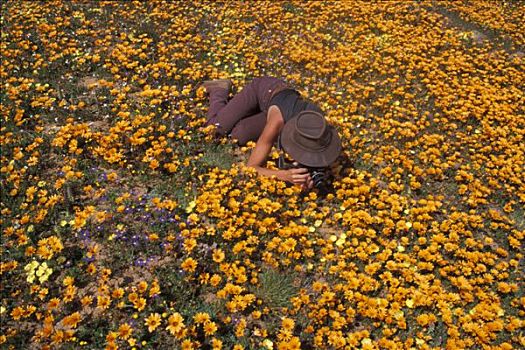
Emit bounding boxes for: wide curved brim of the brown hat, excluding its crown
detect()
[281,116,342,168]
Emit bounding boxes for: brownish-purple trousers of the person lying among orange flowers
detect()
[207,77,286,145]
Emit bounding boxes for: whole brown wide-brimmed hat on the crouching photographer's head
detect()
[280,110,342,167]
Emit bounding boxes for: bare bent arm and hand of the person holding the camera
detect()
[246,108,311,187]
